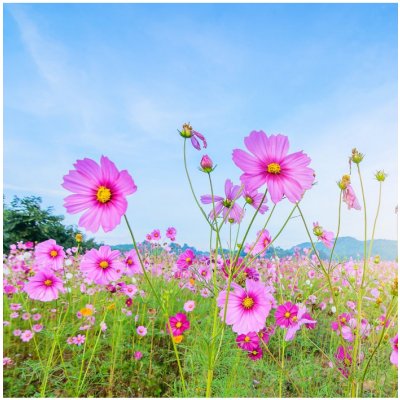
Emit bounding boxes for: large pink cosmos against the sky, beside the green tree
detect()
[62,156,137,232]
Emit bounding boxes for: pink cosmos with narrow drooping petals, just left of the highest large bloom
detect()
[200,179,244,223]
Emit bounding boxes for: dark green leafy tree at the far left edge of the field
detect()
[3,196,98,253]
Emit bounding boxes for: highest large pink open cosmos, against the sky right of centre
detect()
[232,131,314,204]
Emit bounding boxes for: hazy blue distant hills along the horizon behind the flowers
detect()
[111,236,397,261]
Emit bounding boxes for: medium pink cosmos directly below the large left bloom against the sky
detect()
[80,246,124,285]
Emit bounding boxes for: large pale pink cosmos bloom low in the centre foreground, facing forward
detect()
[217,279,274,334]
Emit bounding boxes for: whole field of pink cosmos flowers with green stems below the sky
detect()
[3,124,398,397]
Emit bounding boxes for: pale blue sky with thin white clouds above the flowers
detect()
[4,4,398,248]
